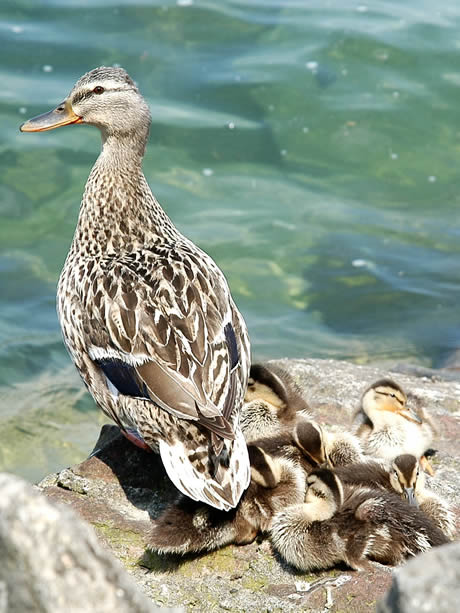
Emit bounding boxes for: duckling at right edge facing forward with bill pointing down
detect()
[334,454,455,538]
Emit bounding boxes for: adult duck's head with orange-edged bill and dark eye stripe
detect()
[20,66,150,152]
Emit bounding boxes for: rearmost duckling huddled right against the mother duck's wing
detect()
[240,364,311,442]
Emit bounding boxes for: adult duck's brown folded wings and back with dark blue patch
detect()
[87,250,252,439]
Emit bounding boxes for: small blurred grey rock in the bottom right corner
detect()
[377,543,460,613]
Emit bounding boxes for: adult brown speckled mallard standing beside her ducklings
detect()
[21,67,250,510]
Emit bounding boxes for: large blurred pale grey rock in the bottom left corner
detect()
[0,473,178,613]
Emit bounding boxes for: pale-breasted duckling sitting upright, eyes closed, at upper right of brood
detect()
[356,379,436,474]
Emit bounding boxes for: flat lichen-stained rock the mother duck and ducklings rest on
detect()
[37,360,460,613]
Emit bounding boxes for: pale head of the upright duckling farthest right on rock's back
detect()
[361,379,421,427]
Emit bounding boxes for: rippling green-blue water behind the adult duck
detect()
[0,0,460,479]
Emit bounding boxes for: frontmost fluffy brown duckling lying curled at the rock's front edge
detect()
[270,469,448,571]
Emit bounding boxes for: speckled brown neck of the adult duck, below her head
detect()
[73,134,177,256]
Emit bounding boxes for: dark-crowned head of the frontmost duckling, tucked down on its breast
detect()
[305,468,344,521]
